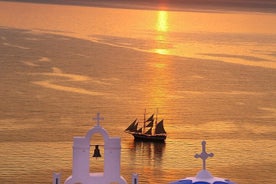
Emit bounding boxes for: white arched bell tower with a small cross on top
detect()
[65,113,127,184]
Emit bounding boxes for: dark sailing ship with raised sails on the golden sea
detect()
[125,112,167,142]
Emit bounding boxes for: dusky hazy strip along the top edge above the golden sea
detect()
[0,0,276,13]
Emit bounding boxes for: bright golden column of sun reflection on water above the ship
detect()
[146,10,171,107]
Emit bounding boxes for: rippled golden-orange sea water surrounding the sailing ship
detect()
[0,2,276,184]
